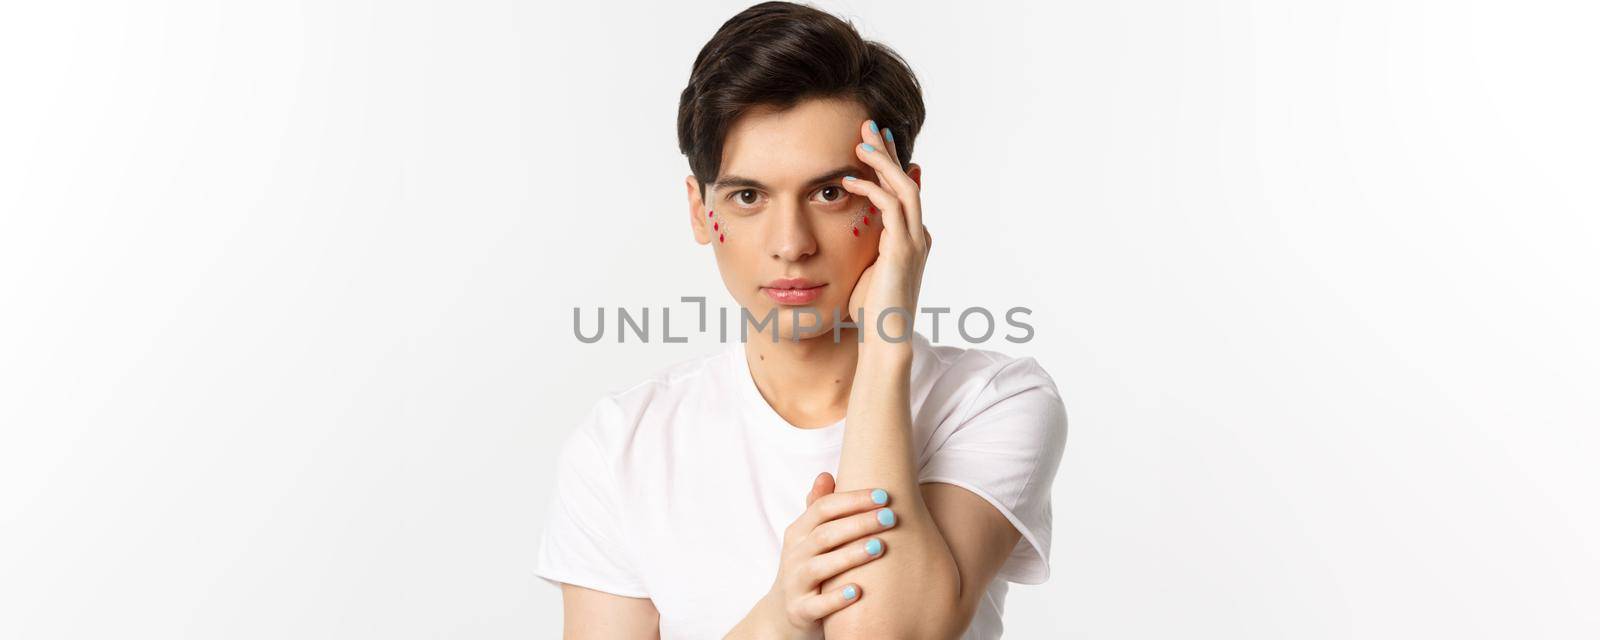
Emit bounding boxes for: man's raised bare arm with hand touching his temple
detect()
[824,123,1021,638]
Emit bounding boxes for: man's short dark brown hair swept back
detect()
[678,2,926,197]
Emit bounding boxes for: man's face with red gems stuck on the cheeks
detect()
[688,99,915,339]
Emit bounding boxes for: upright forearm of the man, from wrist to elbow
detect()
[824,341,970,638]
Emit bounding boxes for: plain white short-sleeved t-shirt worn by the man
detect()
[534,334,1067,640]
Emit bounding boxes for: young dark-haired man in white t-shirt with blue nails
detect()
[538,2,1067,638]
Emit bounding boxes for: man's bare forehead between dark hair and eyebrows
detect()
[720,98,867,186]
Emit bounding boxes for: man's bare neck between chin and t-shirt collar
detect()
[744,331,859,429]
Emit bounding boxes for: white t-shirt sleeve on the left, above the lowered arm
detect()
[534,396,650,598]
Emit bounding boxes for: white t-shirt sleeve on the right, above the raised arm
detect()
[920,358,1067,584]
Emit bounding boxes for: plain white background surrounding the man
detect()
[0,2,1600,638]
